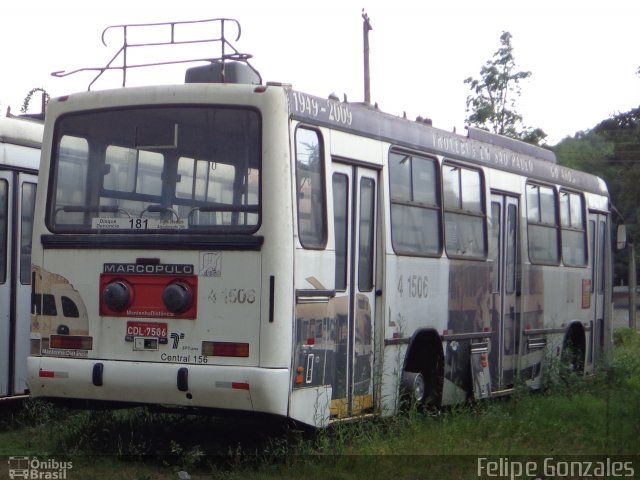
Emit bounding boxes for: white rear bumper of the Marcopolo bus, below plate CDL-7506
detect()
[27,357,290,416]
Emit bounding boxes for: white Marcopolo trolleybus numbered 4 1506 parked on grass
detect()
[28,18,612,426]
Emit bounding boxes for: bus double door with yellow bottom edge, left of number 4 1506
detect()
[331,163,378,417]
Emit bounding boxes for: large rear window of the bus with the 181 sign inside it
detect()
[47,105,261,234]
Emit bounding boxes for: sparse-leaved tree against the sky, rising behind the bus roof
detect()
[464,32,547,145]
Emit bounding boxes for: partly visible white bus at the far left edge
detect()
[0,116,43,400]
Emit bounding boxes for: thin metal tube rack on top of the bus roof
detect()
[51,18,262,90]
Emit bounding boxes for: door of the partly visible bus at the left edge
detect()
[0,171,36,396]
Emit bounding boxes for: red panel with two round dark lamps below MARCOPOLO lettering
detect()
[100,274,198,319]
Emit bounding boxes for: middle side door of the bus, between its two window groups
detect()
[490,193,520,390]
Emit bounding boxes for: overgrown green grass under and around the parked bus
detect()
[0,330,640,480]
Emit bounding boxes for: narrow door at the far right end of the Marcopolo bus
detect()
[583,212,607,363]
